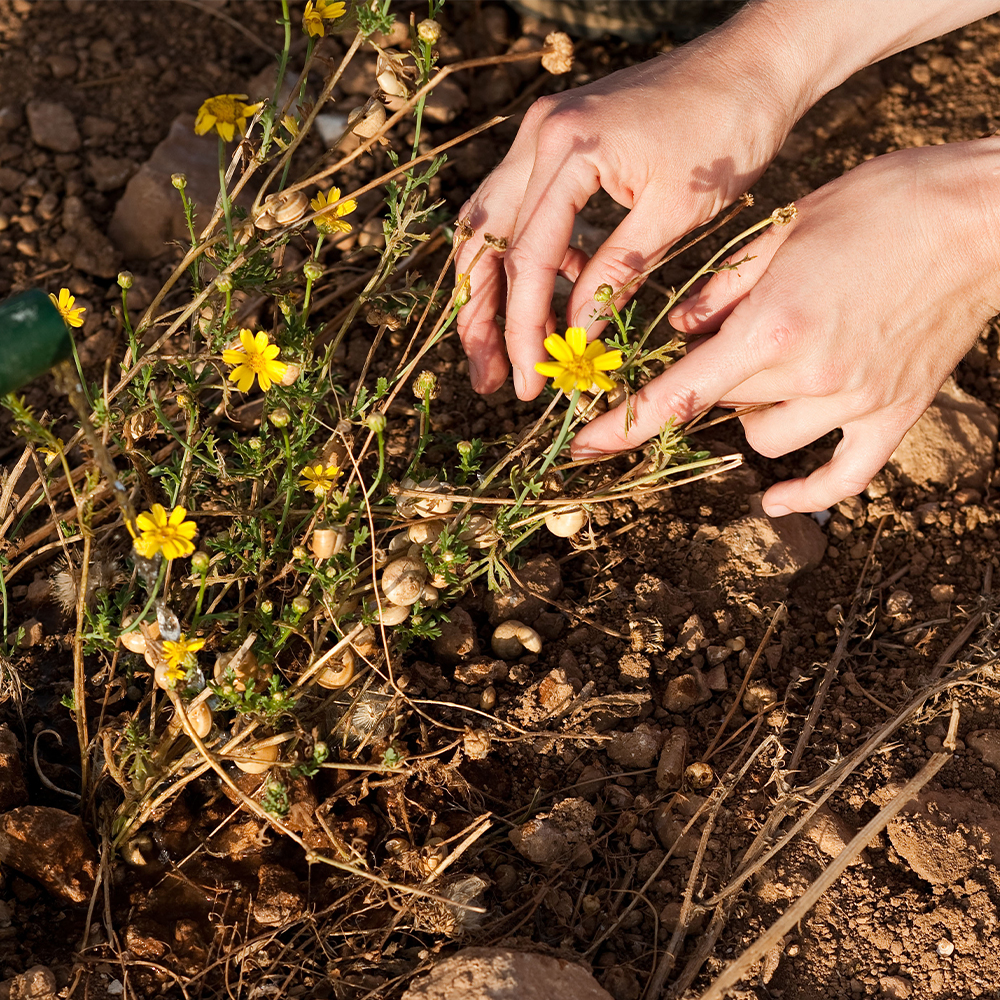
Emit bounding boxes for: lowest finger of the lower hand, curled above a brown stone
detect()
[763,412,908,517]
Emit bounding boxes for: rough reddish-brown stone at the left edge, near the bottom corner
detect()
[0,806,98,903]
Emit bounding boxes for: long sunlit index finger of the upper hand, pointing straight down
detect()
[504,150,600,399]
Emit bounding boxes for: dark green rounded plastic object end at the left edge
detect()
[0,288,73,395]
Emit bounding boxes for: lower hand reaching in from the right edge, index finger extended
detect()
[573,138,1000,516]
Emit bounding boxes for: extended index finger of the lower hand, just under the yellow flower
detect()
[573,322,768,458]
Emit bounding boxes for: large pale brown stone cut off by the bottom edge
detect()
[403,948,613,1000]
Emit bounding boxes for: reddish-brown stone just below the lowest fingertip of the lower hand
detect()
[712,494,826,585]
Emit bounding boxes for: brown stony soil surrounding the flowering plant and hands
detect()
[0,0,1000,1000]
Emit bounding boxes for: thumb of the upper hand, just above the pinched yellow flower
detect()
[566,189,683,336]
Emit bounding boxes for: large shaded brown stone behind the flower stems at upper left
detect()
[108,115,252,260]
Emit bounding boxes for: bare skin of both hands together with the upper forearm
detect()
[456,0,1000,516]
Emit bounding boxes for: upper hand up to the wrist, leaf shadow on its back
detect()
[456,17,803,399]
